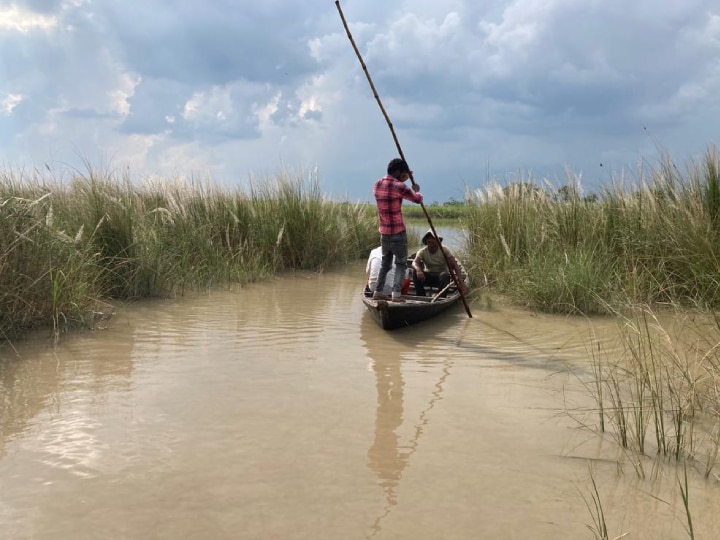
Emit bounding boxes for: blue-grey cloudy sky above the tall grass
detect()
[0,0,720,202]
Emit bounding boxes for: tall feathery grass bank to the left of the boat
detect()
[0,171,377,339]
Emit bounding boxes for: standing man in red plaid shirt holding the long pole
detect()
[373,158,423,302]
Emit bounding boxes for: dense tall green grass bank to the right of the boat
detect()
[463,148,720,314]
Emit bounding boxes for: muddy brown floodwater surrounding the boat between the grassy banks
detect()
[0,264,720,540]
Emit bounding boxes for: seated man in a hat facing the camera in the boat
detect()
[412,229,467,298]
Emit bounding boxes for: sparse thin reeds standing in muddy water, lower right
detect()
[583,306,720,478]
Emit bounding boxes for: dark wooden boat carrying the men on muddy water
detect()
[362,254,469,330]
